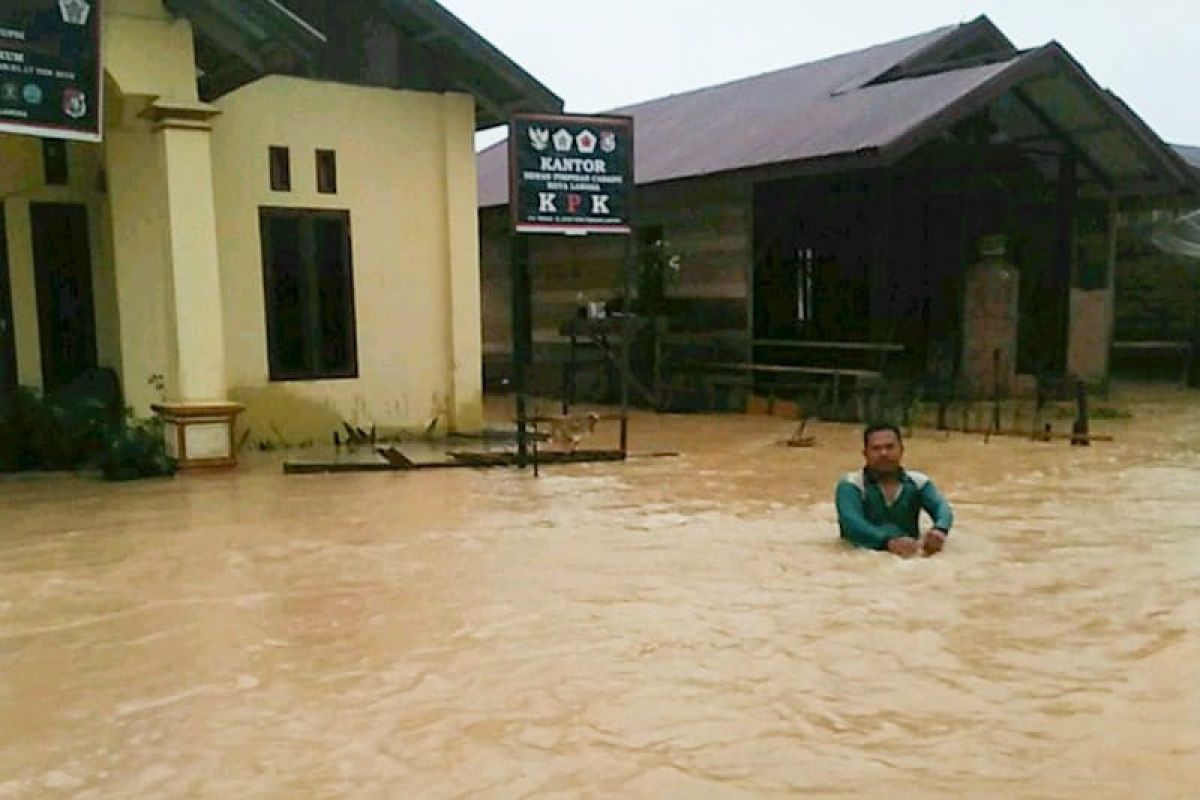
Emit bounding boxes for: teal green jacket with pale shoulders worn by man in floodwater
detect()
[834,469,954,551]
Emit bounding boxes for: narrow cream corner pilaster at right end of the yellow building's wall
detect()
[443,94,484,433]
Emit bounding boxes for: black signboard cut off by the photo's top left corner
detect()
[0,0,102,142]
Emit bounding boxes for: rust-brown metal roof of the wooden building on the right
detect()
[478,18,1198,207]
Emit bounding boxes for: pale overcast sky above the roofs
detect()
[440,0,1200,145]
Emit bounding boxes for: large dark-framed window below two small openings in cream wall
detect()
[259,209,359,380]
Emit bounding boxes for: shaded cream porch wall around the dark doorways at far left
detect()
[0,134,120,390]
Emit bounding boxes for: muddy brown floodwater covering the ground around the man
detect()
[0,386,1200,798]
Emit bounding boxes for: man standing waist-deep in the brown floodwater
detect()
[835,425,954,558]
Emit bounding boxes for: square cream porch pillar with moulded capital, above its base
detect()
[103,0,224,416]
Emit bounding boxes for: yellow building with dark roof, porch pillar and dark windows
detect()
[0,0,562,458]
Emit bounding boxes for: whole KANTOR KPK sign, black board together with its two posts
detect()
[509,114,634,467]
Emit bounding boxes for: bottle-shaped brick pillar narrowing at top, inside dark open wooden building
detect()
[960,236,1020,398]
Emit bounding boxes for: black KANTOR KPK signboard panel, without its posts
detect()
[509,114,634,234]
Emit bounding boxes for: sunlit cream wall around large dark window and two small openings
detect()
[212,77,482,441]
